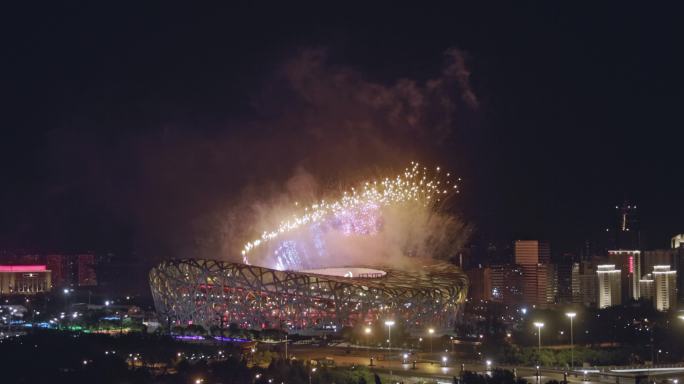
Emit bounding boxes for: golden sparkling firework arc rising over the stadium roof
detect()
[242,162,458,269]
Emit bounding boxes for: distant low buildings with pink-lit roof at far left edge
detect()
[0,253,97,295]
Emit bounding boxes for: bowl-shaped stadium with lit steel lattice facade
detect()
[150,259,468,329]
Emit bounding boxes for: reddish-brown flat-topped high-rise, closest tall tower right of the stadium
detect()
[515,240,557,306]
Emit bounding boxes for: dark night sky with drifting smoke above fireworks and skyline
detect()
[0,2,684,258]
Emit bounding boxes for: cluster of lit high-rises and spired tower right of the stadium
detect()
[467,203,684,311]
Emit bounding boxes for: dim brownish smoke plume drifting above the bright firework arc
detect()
[29,49,478,261]
